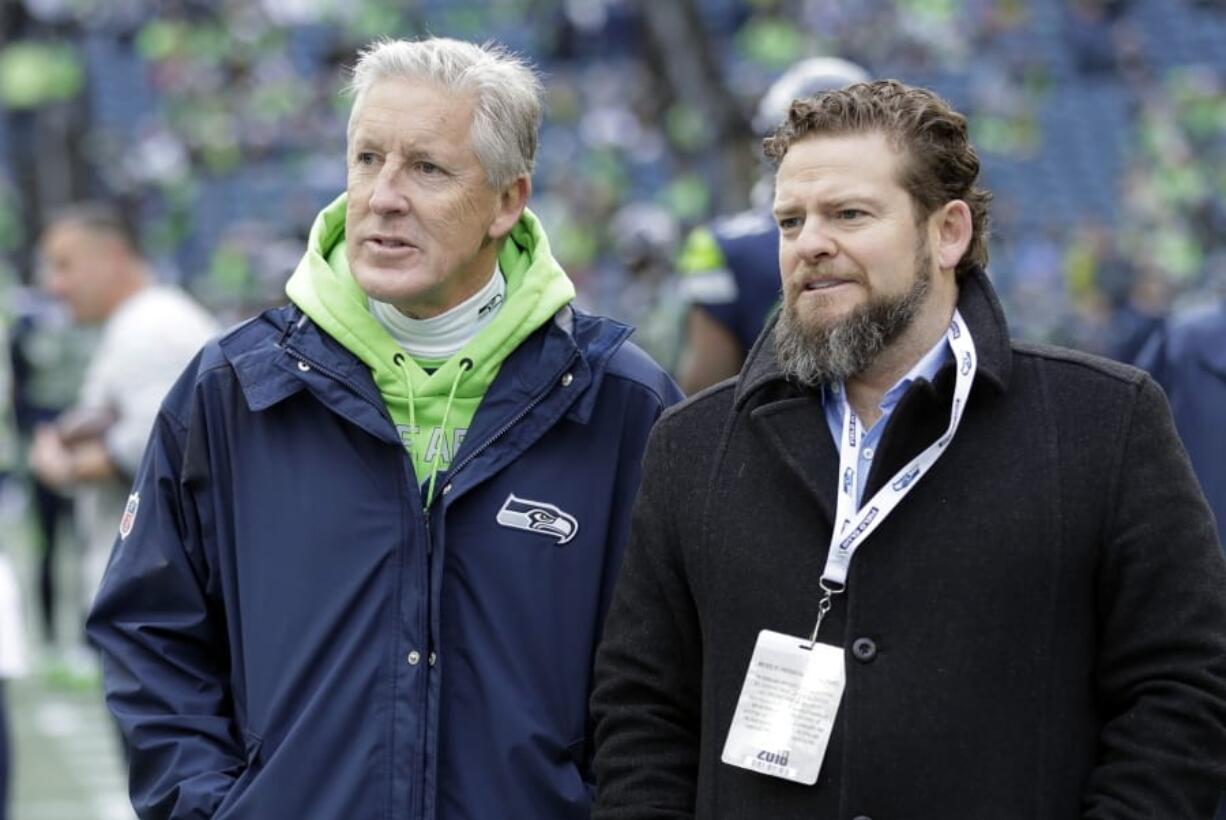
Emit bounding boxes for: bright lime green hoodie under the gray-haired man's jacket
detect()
[286,194,575,505]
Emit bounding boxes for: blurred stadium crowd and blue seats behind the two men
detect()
[0,0,1226,813]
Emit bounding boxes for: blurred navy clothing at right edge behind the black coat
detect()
[1137,304,1226,534]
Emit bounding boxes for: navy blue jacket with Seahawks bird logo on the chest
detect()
[88,302,680,820]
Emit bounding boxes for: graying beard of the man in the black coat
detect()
[775,262,932,387]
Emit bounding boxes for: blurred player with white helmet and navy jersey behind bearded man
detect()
[677,56,868,393]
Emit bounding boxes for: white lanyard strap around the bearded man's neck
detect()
[809,310,978,643]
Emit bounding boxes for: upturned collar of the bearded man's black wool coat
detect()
[736,267,1013,408]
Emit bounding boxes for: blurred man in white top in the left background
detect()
[29,202,217,647]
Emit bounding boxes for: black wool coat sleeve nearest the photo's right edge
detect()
[1084,378,1226,820]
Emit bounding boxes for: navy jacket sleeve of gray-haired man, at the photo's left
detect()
[87,399,245,820]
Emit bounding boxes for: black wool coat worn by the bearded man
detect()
[592,265,1226,820]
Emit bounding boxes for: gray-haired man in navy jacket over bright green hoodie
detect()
[89,38,680,820]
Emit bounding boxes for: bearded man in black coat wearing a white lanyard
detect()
[592,81,1226,820]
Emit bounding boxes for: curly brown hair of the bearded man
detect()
[763,80,992,278]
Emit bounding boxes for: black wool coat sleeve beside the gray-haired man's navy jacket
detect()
[592,419,701,820]
